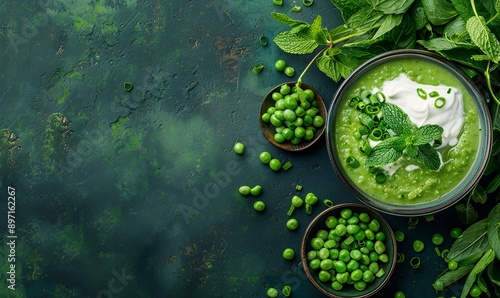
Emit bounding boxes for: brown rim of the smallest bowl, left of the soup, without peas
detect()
[259,81,328,151]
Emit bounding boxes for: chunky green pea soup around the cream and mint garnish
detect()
[332,57,481,205]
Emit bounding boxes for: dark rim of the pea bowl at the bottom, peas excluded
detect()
[300,202,397,298]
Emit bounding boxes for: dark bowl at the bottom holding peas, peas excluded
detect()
[300,203,397,298]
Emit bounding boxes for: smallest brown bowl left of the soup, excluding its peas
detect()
[259,82,327,151]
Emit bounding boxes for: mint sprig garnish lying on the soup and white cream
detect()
[366,103,443,171]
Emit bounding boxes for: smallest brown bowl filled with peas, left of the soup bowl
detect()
[260,82,327,151]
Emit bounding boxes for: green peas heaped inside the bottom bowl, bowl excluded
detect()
[307,208,389,291]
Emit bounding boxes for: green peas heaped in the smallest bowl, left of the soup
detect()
[261,84,325,145]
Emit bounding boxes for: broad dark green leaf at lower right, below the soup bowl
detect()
[448,219,489,262]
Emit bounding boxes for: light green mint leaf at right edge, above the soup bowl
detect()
[466,16,500,63]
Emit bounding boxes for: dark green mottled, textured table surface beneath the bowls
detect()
[0,0,494,297]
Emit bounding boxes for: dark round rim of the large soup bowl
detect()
[326,49,493,216]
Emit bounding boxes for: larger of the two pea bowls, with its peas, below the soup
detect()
[300,203,397,298]
